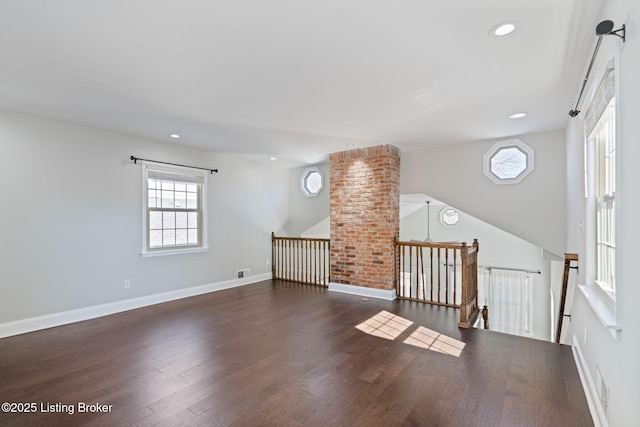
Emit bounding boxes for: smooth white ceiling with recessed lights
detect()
[0,0,604,164]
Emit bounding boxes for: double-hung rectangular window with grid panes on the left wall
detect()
[142,164,207,256]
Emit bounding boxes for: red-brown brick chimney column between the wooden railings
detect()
[330,145,400,291]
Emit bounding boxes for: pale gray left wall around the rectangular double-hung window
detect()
[0,111,289,324]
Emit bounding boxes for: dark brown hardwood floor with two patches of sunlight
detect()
[0,281,593,427]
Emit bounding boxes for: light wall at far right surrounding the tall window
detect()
[566,0,640,427]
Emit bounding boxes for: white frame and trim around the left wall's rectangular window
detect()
[140,162,209,257]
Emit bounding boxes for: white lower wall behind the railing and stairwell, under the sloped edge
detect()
[400,203,551,341]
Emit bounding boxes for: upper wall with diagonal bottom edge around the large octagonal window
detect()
[400,131,566,255]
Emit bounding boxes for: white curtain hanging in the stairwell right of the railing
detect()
[480,269,531,335]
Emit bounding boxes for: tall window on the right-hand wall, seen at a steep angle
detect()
[585,70,616,300]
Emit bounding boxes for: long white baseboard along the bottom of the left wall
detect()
[0,273,271,338]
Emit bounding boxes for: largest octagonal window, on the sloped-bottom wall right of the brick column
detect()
[484,139,533,184]
